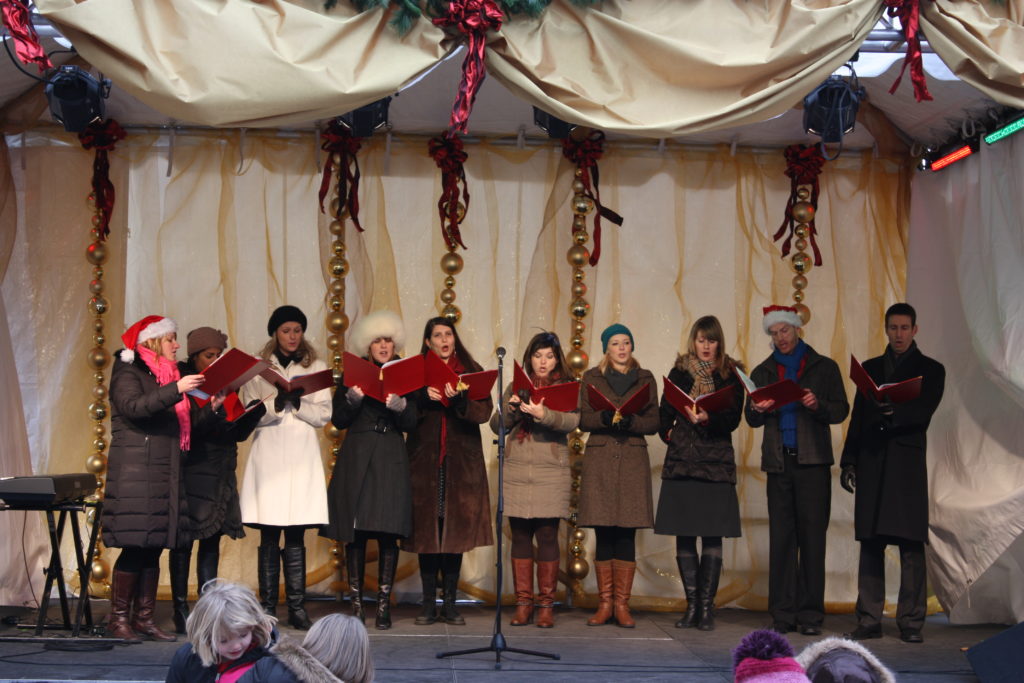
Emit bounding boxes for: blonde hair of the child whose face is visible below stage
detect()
[185,579,278,667]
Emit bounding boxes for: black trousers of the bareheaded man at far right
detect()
[857,538,928,631]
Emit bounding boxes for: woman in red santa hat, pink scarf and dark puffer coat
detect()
[102,315,206,642]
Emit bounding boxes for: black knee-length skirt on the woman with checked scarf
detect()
[654,479,742,538]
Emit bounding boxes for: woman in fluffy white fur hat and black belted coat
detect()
[321,310,416,631]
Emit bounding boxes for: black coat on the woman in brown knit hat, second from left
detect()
[178,362,266,540]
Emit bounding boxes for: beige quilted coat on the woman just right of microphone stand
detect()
[490,385,580,519]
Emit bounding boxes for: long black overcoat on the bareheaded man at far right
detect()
[840,344,946,543]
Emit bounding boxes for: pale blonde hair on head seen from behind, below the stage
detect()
[302,614,374,683]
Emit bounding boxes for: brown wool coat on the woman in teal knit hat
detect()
[579,368,659,528]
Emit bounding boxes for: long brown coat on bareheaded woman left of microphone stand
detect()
[401,364,495,553]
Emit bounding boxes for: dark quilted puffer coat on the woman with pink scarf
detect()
[102,355,201,548]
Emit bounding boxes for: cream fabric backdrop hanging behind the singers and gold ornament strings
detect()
[3,134,908,609]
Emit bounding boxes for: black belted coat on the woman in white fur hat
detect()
[321,370,417,543]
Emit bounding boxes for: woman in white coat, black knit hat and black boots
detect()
[241,306,331,629]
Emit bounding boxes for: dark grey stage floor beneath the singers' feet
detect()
[0,600,1008,683]
